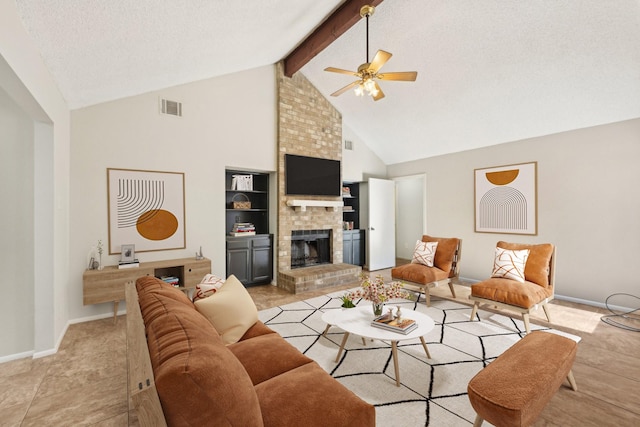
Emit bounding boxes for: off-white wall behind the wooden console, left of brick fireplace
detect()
[69,66,277,319]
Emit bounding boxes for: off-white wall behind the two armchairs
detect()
[388,119,640,304]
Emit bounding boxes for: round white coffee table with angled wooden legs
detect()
[331,305,435,387]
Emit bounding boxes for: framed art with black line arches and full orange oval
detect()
[107,168,186,255]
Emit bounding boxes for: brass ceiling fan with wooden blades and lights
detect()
[324,5,418,101]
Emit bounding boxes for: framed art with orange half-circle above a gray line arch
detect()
[475,162,538,235]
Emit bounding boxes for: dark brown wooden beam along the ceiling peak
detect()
[284,0,383,77]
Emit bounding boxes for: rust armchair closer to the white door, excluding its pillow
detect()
[391,234,462,306]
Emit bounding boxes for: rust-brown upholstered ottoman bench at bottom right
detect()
[467,331,578,427]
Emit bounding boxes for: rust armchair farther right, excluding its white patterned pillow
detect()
[469,241,556,333]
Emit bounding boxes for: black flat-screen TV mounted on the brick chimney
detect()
[284,154,342,196]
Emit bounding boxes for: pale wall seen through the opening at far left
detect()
[0,90,34,356]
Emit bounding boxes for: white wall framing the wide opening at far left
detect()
[0,0,70,357]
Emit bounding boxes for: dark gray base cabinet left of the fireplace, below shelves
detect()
[227,234,273,286]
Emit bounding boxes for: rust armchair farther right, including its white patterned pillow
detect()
[469,241,556,333]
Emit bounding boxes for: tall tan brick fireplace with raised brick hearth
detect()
[276,63,361,293]
